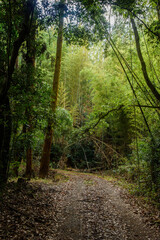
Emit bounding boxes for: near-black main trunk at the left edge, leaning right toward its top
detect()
[0,0,35,185]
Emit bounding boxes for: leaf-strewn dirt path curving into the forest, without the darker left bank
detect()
[49,173,160,240]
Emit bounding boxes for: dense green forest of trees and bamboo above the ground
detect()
[0,0,160,202]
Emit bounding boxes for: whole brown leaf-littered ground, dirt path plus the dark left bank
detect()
[0,172,160,240]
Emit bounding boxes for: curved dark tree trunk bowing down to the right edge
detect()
[131,18,160,102]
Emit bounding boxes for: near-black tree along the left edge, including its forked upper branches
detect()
[0,0,36,184]
